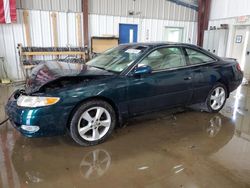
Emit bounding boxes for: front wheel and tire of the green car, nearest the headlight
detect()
[69,100,116,146]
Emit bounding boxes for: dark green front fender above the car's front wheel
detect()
[54,78,128,122]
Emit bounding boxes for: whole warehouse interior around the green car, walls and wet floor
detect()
[0,0,250,188]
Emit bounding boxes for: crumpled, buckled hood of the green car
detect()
[26,61,114,94]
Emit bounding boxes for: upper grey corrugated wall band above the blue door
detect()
[89,0,197,21]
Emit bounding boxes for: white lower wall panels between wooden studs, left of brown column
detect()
[0,10,83,80]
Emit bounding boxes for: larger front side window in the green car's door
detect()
[138,47,186,71]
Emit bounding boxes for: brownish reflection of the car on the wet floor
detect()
[9,112,234,187]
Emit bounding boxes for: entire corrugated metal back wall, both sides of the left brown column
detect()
[0,0,197,80]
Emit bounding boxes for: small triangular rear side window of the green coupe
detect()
[186,48,214,65]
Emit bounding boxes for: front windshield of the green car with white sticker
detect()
[86,45,147,73]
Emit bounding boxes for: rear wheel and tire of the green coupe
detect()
[204,83,228,113]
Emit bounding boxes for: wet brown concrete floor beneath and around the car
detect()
[0,86,250,188]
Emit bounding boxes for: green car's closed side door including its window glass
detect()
[128,47,192,115]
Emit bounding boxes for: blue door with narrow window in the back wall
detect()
[119,24,138,44]
